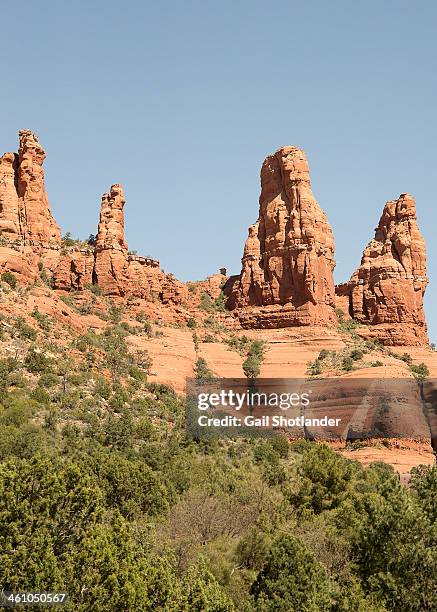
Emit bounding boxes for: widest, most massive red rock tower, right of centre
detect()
[226,147,335,327]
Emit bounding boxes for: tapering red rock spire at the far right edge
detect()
[337,194,428,345]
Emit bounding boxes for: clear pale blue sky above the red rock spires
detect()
[0,0,437,340]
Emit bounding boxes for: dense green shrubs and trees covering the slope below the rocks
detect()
[0,296,437,612]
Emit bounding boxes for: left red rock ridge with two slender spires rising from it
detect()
[0,130,187,304]
